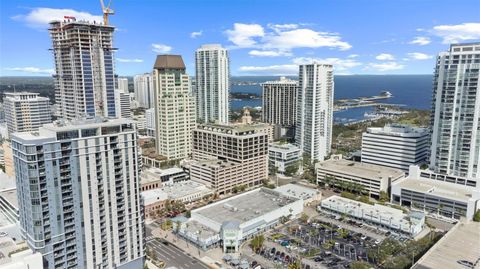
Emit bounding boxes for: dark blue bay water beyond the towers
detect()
[231,75,432,122]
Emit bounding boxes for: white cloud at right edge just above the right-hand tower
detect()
[432,22,480,44]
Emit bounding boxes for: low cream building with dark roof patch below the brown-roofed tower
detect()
[140,167,189,191]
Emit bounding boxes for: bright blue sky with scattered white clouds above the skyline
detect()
[0,0,480,76]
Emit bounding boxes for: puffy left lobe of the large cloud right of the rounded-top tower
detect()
[225,23,265,48]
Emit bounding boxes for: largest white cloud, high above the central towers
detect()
[225,23,352,52]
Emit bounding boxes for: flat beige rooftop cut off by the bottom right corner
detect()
[413,221,480,269]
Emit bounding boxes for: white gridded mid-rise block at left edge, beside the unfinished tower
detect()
[3,92,52,135]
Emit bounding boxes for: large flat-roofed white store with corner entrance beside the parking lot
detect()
[179,188,303,252]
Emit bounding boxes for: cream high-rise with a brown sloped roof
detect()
[153,55,196,159]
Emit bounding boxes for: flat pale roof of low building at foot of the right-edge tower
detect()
[394,176,475,201]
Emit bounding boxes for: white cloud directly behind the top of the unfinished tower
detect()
[12,7,103,28]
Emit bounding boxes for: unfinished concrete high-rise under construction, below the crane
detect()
[49,20,116,119]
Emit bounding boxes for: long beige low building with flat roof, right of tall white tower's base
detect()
[316,159,405,197]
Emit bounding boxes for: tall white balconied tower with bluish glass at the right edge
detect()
[430,43,480,179]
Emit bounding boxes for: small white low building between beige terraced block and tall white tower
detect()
[268,142,302,174]
